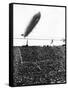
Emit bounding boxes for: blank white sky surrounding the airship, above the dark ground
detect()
[13,4,65,46]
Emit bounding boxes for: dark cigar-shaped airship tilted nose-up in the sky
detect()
[21,12,41,37]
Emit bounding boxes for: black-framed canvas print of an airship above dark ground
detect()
[9,3,66,87]
